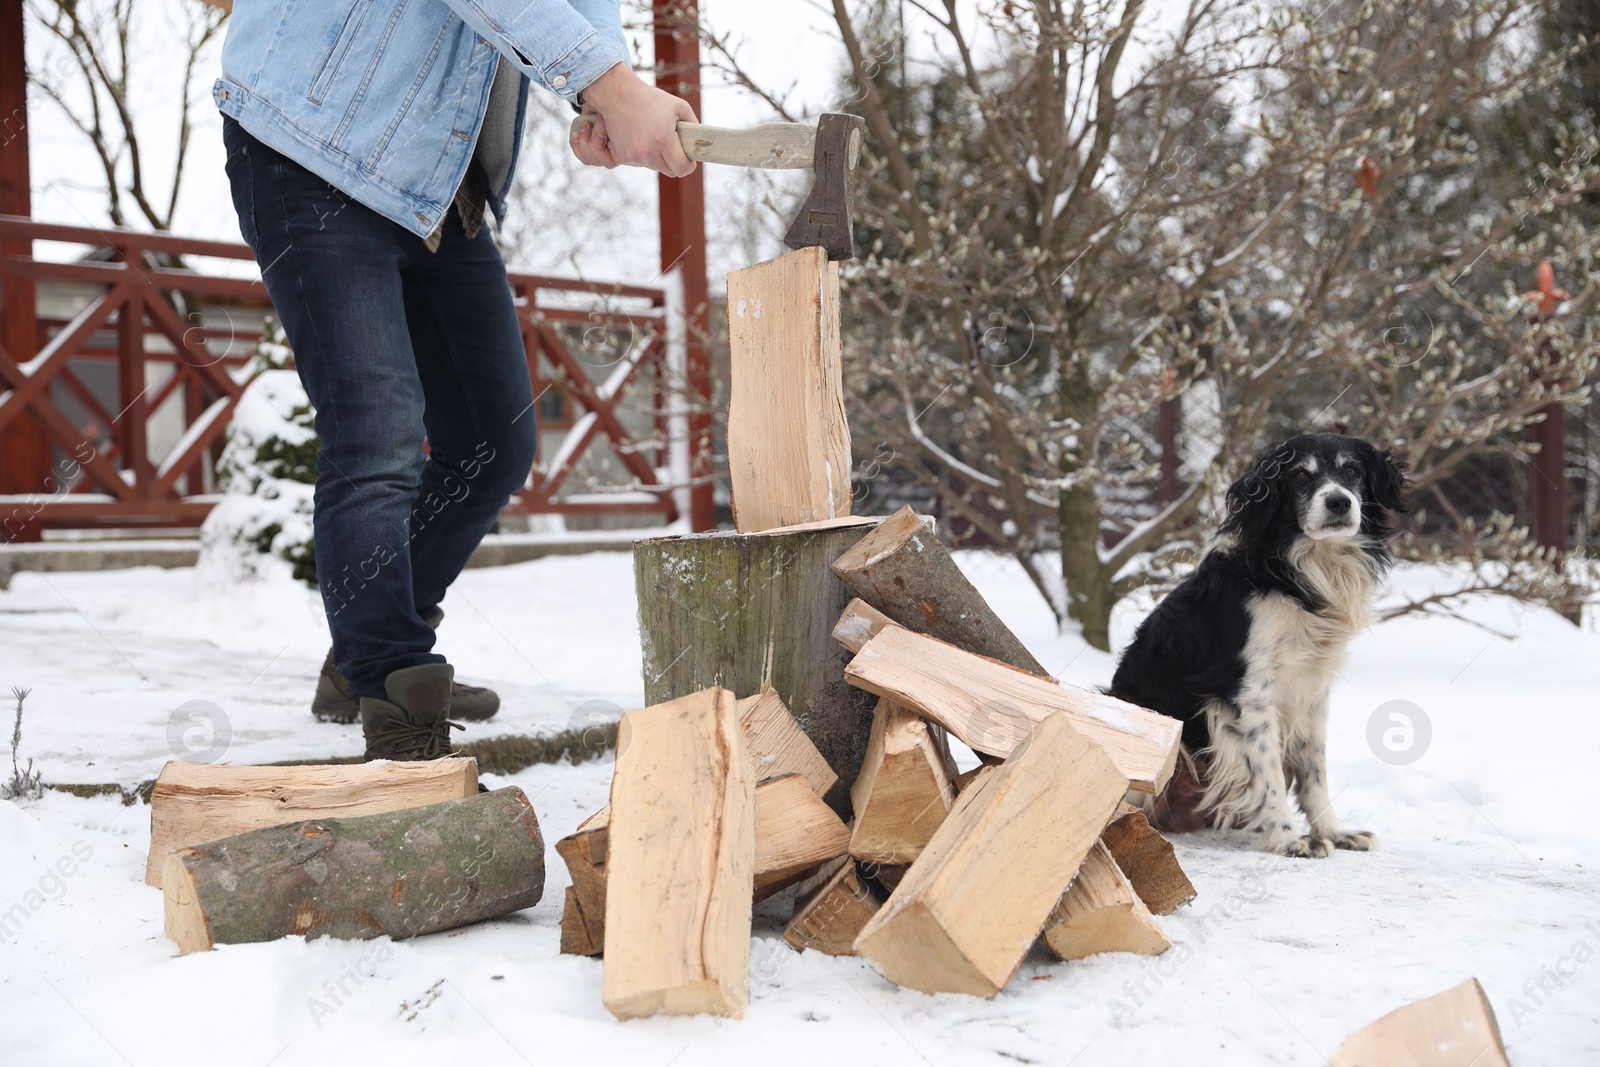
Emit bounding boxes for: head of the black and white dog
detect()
[1222,434,1408,542]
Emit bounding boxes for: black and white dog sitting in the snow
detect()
[1110,434,1406,856]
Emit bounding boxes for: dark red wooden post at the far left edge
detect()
[0,0,53,541]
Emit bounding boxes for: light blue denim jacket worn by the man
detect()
[211,0,627,237]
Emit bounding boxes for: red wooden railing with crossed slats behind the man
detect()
[0,214,675,541]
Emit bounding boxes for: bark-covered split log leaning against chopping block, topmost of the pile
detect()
[834,507,1050,678]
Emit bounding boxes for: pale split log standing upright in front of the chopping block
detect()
[602,688,755,1019]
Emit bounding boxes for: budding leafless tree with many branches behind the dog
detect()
[707,0,1600,648]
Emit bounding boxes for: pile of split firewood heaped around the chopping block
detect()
[555,509,1194,1017]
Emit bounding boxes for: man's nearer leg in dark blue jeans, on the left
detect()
[224,120,443,713]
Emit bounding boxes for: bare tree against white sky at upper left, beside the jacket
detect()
[27,0,227,230]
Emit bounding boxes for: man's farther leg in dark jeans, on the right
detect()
[402,213,538,633]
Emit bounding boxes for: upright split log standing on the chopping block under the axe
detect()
[728,248,851,533]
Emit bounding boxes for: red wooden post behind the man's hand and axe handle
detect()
[651,0,717,531]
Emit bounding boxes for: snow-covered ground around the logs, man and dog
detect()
[0,552,1600,1067]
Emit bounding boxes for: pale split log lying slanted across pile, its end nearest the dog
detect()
[845,624,1182,795]
